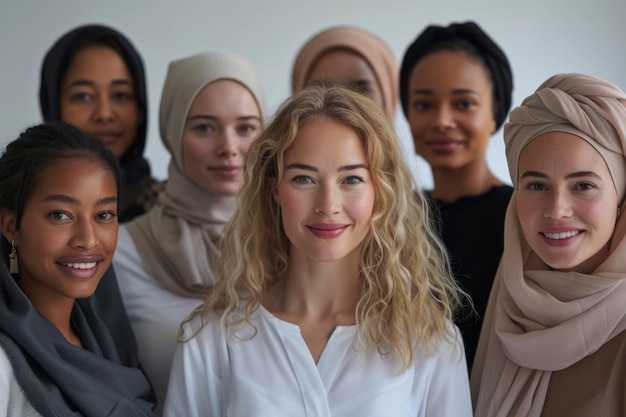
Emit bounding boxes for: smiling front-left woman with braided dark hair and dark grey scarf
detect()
[0,122,155,417]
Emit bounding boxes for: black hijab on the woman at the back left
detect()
[39,25,150,182]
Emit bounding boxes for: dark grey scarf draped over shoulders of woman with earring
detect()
[0,237,156,417]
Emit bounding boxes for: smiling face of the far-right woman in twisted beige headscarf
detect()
[516,132,617,273]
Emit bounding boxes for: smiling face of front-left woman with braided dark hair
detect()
[2,158,118,310]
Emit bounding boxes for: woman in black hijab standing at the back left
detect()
[39,25,162,222]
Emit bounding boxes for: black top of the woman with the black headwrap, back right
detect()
[426,185,513,369]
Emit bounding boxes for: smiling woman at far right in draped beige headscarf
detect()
[471,74,626,417]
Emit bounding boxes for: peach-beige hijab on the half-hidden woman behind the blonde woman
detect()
[291,26,398,121]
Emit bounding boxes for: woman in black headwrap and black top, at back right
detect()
[400,22,513,368]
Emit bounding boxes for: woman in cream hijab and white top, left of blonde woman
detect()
[114,53,263,412]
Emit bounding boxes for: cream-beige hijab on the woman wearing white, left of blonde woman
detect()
[127,53,263,298]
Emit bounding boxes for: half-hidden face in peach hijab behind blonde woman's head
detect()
[308,48,385,108]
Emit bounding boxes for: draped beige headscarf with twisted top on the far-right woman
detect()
[471,74,626,417]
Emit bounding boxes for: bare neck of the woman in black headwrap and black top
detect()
[432,160,502,203]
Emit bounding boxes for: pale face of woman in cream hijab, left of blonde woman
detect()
[182,80,262,196]
